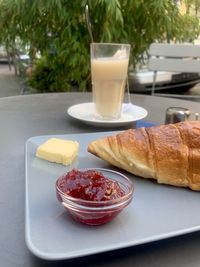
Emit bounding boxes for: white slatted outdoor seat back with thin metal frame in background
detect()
[148,43,200,98]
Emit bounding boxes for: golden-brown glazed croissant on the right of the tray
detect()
[88,121,200,191]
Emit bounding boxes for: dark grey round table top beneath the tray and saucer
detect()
[0,93,200,267]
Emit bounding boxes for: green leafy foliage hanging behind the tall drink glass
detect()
[0,0,200,92]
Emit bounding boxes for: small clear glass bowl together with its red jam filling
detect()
[56,168,133,225]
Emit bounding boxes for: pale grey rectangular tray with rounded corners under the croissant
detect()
[25,132,200,260]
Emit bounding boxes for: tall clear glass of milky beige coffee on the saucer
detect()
[90,43,130,120]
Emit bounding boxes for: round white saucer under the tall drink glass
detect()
[67,103,148,127]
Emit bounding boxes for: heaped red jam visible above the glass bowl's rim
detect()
[58,169,125,201]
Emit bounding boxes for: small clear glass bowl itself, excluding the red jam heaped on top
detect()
[56,168,133,225]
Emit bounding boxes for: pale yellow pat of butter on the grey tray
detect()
[36,138,79,165]
